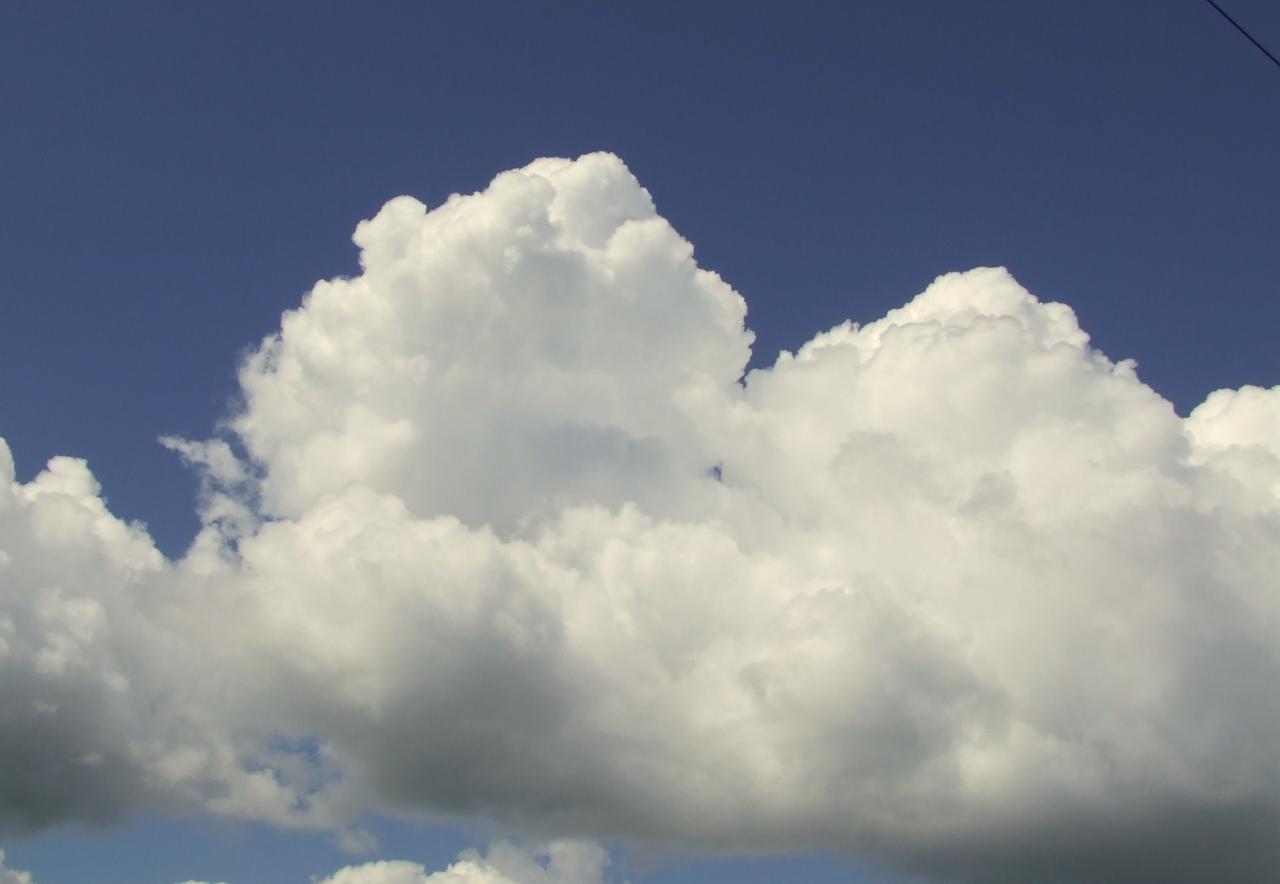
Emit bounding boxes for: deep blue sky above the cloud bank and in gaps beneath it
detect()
[0,0,1280,884]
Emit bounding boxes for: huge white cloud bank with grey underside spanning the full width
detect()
[0,154,1280,883]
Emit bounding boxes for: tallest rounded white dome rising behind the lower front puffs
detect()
[233,154,751,528]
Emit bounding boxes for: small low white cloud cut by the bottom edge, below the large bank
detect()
[316,841,608,884]
